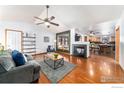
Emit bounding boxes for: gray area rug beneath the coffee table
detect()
[40,61,76,83]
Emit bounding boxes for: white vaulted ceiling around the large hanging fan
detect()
[0,5,124,31]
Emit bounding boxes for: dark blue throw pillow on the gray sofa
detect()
[12,50,25,66]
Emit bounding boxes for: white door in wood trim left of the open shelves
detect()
[5,29,22,52]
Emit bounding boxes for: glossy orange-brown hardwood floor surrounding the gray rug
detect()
[36,53,124,84]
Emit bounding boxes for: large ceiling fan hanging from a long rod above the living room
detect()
[34,5,59,28]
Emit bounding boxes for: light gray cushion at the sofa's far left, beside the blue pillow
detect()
[0,57,15,73]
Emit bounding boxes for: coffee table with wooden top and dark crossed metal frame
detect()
[44,53,64,70]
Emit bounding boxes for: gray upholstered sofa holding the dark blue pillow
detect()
[0,53,40,83]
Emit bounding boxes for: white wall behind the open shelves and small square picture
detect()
[0,21,55,53]
